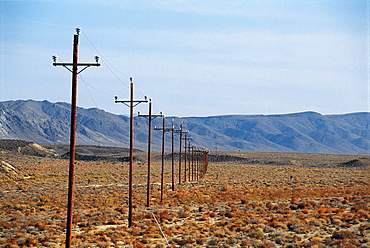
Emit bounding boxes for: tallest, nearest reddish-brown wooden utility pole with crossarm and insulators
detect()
[53,28,100,248]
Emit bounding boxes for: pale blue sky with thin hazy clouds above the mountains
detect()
[0,0,370,116]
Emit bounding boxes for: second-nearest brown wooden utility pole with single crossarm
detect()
[115,77,148,227]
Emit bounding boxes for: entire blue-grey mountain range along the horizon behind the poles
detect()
[0,100,370,154]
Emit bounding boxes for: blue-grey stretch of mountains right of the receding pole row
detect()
[177,112,370,154]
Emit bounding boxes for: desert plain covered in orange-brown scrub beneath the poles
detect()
[0,146,370,248]
